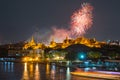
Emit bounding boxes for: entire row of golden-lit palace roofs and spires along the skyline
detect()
[23,37,106,50]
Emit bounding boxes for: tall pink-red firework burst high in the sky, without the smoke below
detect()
[71,3,93,37]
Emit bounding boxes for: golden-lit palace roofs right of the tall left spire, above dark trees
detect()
[48,37,106,48]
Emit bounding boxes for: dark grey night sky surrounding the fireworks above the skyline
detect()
[0,0,120,43]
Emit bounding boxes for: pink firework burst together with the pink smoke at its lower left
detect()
[50,3,93,42]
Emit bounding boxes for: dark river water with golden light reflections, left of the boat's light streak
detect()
[0,62,103,80]
